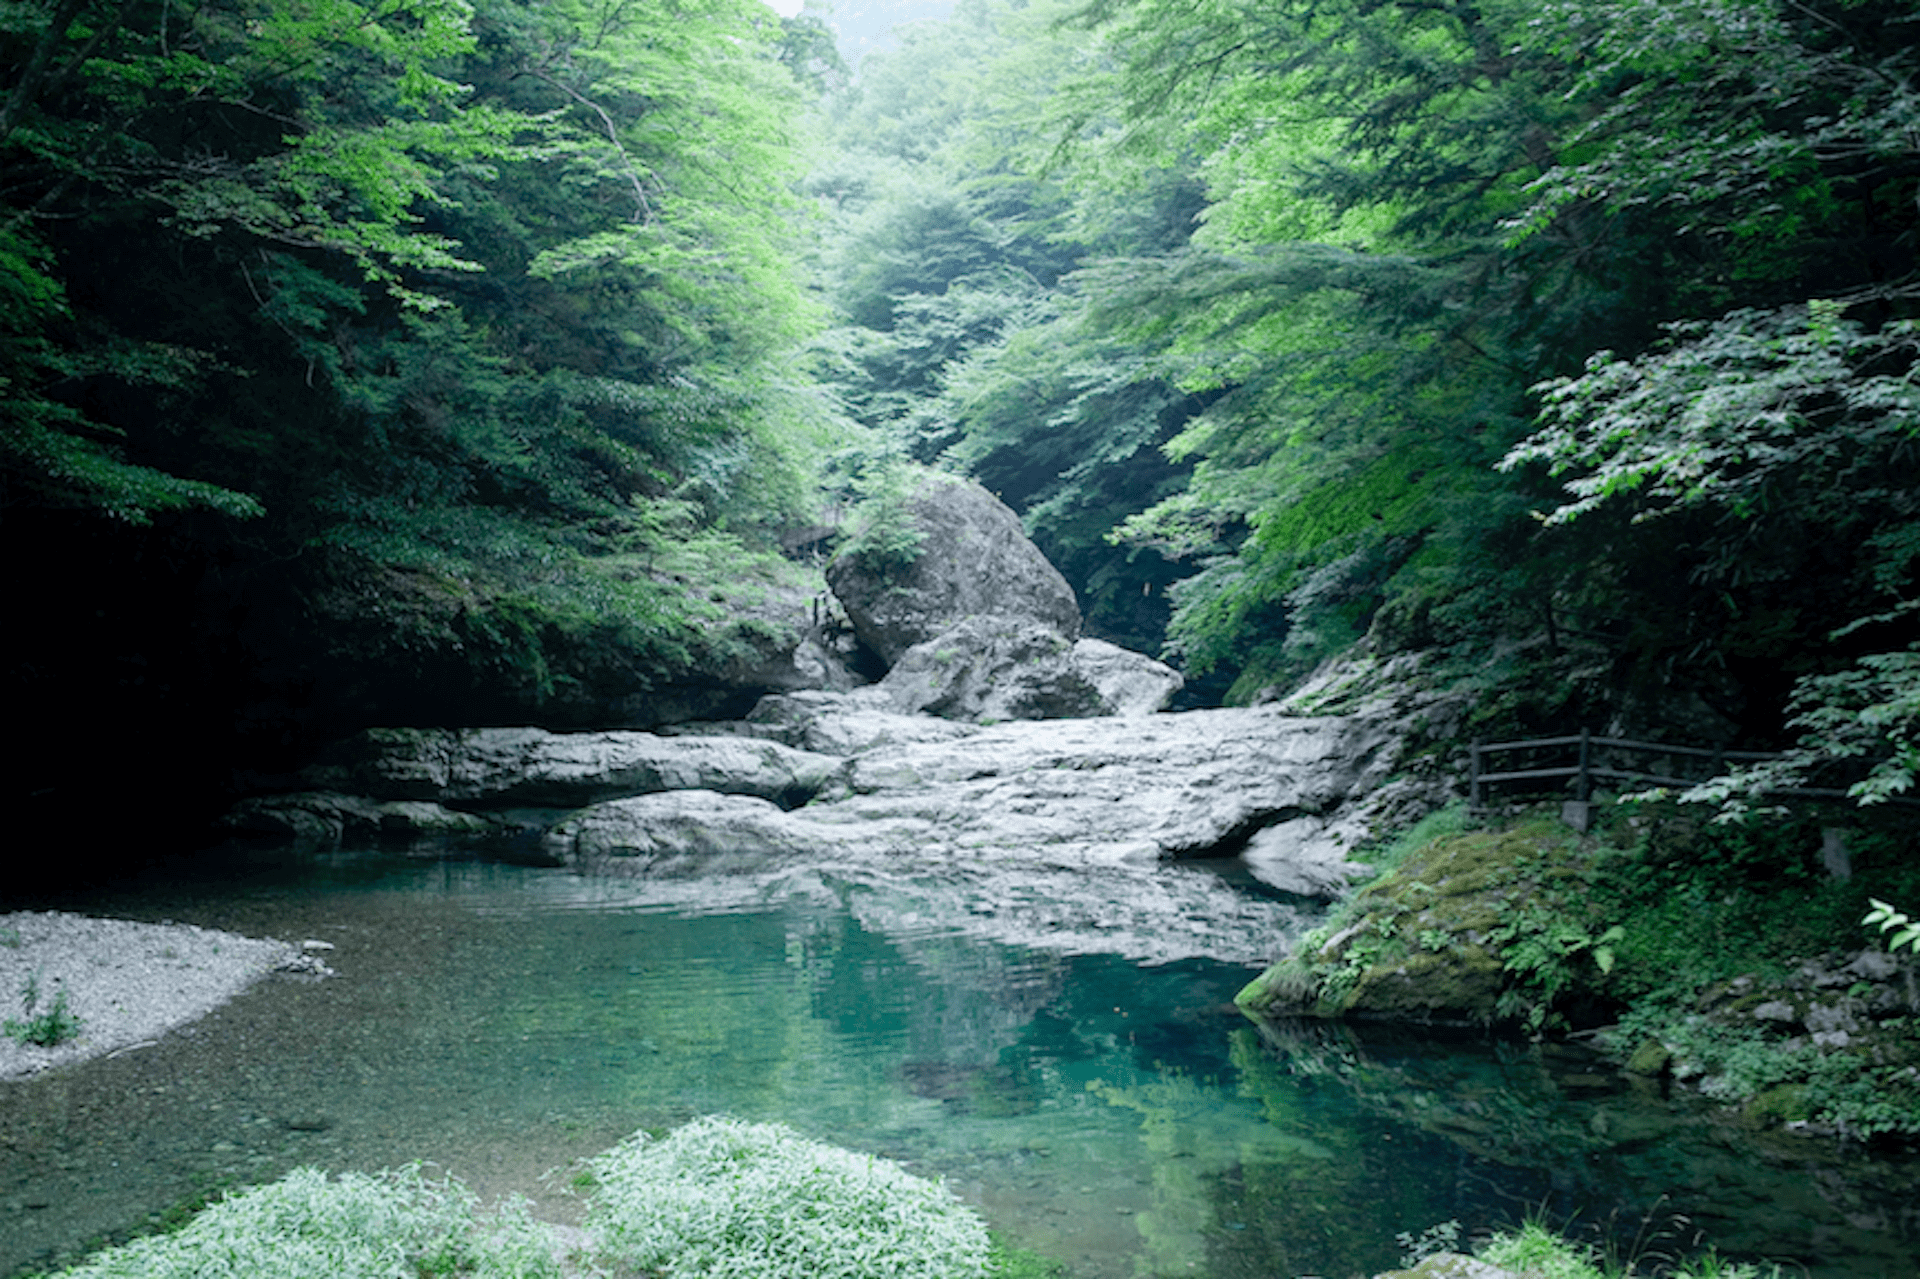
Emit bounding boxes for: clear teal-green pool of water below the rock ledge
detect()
[0,855,1916,1279]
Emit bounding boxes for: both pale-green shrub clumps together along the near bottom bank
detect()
[30,1118,1006,1279]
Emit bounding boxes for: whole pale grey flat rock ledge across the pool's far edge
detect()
[227,688,1402,917]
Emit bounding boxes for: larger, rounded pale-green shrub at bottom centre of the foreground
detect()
[588,1118,989,1279]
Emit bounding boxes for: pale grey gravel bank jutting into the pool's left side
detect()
[0,910,326,1079]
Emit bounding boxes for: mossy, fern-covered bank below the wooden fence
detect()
[1240,805,1920,1139]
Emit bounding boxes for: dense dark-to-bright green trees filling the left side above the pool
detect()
[0,0,848,837]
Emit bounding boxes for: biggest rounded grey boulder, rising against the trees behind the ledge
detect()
[828,472,1081,666]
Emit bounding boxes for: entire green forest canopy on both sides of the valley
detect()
[0,0,1920,825]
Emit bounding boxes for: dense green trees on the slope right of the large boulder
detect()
[814,0,1920,799]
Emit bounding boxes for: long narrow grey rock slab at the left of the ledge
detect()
[303,728,839,808]
